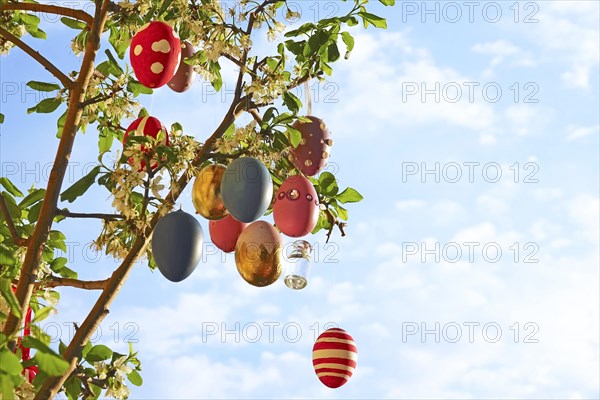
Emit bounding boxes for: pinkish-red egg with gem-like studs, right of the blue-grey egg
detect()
[273,175,319,237]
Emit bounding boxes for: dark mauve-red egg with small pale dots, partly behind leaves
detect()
[291,116,333,176]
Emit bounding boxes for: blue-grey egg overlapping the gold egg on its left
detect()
[221,157,273,222]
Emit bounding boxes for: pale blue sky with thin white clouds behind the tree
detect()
[0,1,600,399]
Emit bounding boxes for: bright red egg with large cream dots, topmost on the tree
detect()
[129,21,181,89]
